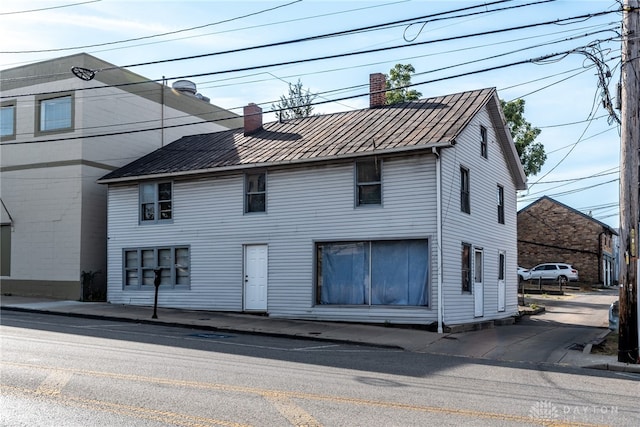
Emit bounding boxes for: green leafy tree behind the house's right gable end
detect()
[500,99,547,176]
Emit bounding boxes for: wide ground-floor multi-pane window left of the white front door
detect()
[123,247,190,290]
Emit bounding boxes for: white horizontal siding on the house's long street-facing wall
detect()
[108,155,436,323]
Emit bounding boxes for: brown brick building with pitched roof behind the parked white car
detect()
[518,196,618,286]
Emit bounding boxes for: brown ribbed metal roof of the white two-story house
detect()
[98,88,524,183]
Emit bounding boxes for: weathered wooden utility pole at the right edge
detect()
[618,0,640,363]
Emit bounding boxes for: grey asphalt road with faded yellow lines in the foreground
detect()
[0,311,640,426]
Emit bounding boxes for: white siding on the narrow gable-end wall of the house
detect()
[442,106,517,325]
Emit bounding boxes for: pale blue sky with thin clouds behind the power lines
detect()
[0,0,622,228]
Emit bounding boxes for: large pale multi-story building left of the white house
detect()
[0,54,242,299]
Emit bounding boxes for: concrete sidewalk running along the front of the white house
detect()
[0,290,640,373]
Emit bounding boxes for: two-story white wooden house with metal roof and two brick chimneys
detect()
[99,74,526,330]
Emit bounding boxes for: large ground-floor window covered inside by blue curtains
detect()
[316,240,429,306]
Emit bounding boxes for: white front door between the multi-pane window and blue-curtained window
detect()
[244,245,268,311]
